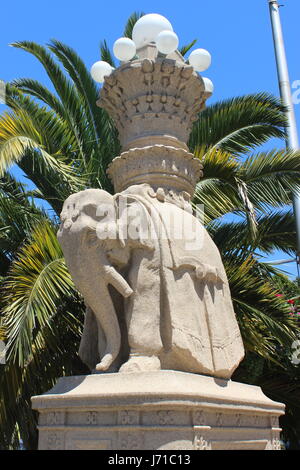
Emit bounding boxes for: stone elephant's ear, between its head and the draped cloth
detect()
[115,194,154,250]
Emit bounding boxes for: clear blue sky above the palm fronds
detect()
[0,0,300,274]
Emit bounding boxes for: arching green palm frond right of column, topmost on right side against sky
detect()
[189,93,287,155]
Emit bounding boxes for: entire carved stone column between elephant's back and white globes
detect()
[98,50,210,196]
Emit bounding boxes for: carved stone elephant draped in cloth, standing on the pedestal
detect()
[58,184,244,378]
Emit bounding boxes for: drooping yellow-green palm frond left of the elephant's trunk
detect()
[3,222,75,367]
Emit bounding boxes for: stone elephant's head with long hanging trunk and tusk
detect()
[57,189,132,371]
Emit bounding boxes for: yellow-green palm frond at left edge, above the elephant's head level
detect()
[0,88,85,211]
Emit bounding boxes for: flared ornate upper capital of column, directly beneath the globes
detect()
[97,58,210,150]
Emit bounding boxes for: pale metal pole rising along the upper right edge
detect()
[268,0,300,262]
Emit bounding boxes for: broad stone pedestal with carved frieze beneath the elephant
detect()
[32,371,284,451]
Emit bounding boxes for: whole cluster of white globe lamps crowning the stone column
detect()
[91,13,214,93]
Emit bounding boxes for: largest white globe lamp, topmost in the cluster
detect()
[132,13,173,49]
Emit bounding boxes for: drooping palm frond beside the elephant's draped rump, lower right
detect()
[223,253,298,363]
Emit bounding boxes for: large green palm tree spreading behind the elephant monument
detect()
[0,14,300,448]
